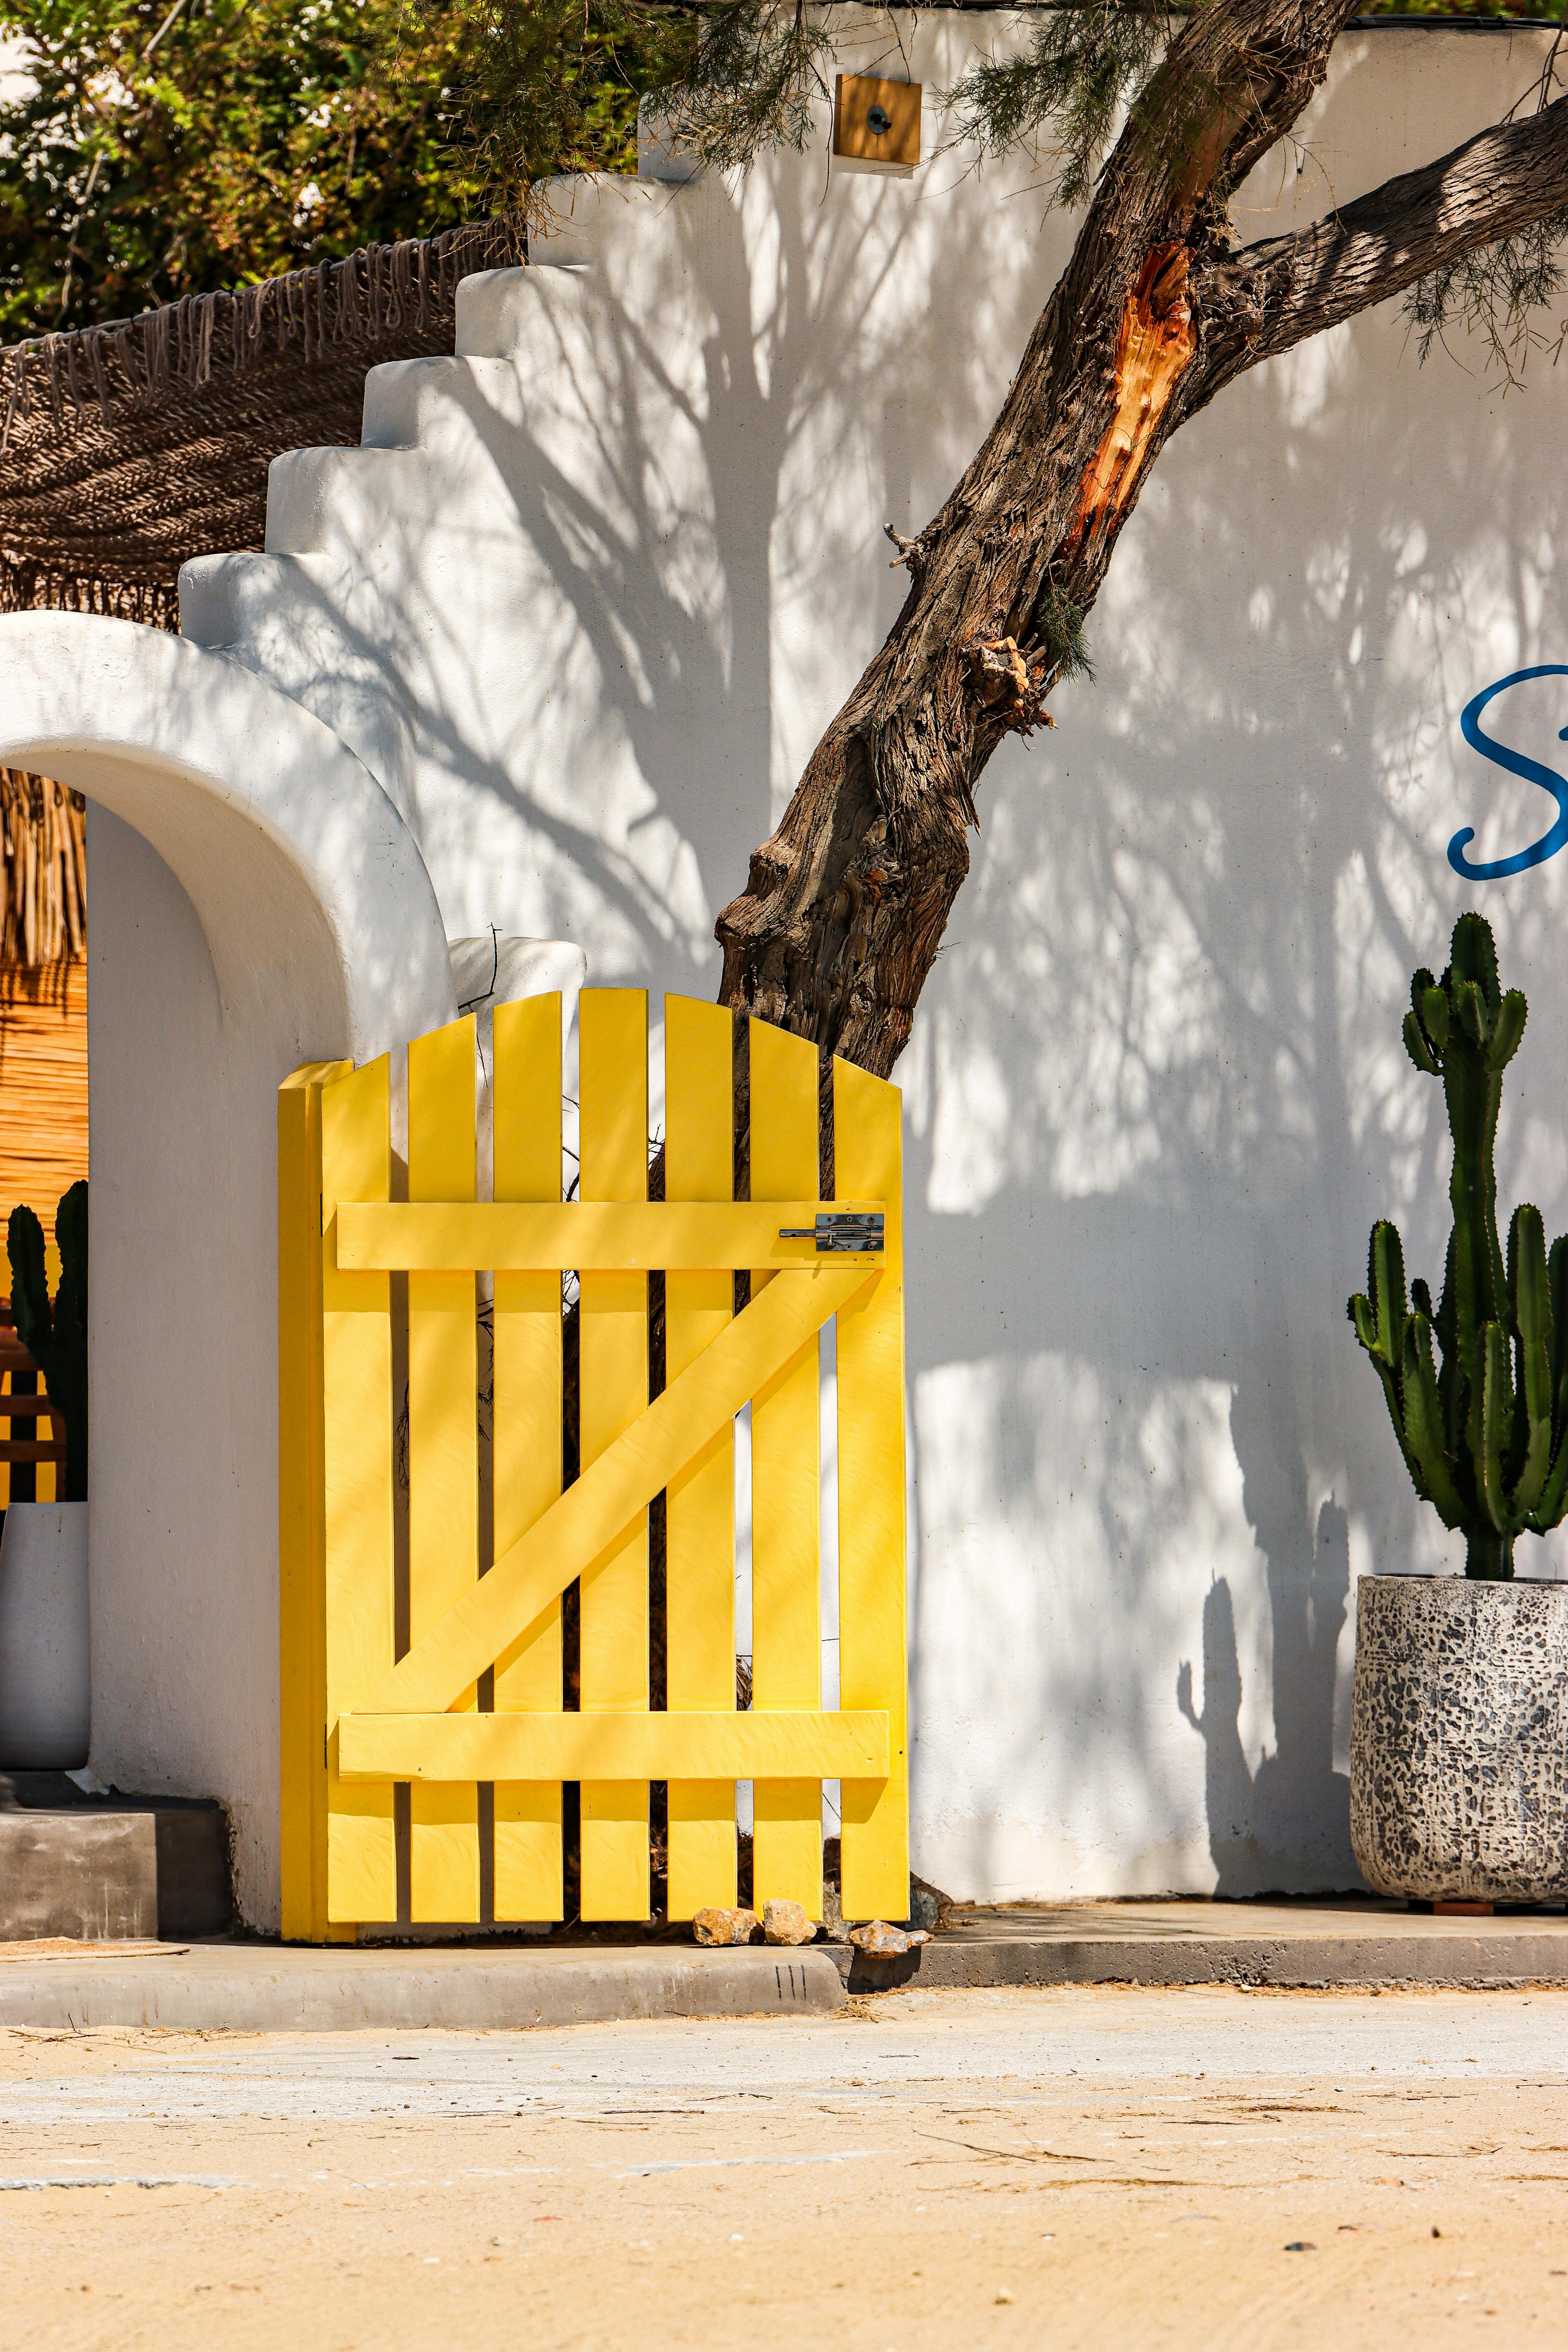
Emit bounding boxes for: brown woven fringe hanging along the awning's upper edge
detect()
[0,214,524,454]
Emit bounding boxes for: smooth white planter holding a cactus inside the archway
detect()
[0,1503,92,1771]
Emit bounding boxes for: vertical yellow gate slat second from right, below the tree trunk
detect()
[750,1021,823,1919]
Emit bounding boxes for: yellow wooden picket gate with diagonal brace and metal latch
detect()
[277,988,910,1940]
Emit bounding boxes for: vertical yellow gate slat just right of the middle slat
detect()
[665,997,738,1919]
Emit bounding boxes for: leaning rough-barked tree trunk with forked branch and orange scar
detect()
[717,0,1568,1077]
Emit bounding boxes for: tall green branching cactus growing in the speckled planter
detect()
[1349,915,1568,1578]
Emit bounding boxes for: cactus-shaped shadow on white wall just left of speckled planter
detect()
[1175,1503,1361,1896]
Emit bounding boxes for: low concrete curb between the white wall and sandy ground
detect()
[0,1898,1568,2032]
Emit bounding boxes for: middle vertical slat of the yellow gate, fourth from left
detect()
[578,988,649,1919]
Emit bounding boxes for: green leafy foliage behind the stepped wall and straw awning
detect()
[0,0,670,341]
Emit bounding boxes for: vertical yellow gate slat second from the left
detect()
[409,1014,480,1924]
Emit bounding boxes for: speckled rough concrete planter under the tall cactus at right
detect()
[1349,1576,1568,1903]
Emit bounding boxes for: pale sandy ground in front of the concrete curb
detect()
[0,1990,1568,2352]
